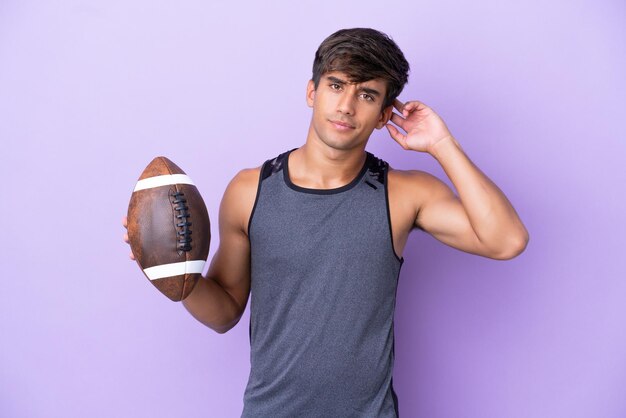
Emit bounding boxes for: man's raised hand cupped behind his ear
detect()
[385,99,452,154]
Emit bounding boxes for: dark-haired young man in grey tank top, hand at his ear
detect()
[123,29,528,417]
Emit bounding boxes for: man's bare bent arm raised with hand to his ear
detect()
[387,100,529,259]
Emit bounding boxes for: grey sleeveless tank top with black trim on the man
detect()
[241,148,404,418]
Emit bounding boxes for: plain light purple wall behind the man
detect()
[0,0,626,418]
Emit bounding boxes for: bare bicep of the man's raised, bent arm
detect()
[415,175,489,256]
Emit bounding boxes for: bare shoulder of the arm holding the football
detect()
[220,166,262,234]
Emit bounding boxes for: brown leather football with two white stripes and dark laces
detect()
[127,157,211,302]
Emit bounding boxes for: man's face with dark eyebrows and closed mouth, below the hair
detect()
[307,71,392,150]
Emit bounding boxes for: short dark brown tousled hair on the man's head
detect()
[312,28,409,109]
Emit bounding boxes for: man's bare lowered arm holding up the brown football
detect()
[183,168,260,334]
